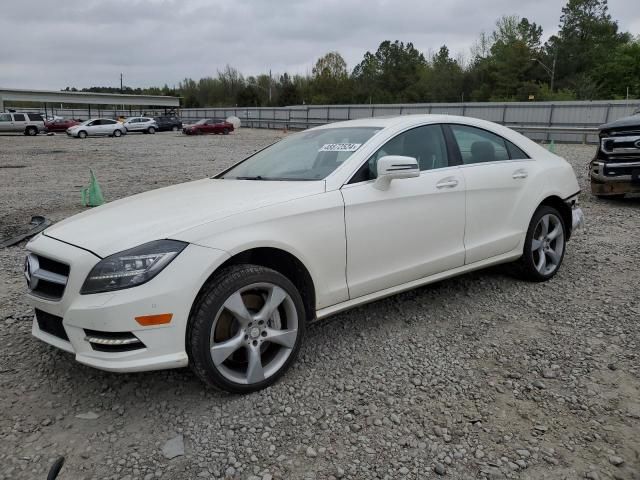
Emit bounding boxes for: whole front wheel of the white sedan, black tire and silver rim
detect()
[186,265,306,393]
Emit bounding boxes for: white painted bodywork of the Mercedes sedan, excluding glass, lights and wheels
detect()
[27,115,579,371]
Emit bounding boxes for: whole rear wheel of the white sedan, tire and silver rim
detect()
[517,205,567,282]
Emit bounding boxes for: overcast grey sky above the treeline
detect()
[0,0,640,89]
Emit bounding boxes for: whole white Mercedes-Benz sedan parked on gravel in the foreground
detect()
[25,115,583,392]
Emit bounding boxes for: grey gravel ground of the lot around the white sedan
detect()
[0,130,640,480]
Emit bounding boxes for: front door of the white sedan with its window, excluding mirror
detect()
[341,125,465,299]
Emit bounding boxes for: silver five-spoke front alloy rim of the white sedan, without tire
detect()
[209,283,298,385]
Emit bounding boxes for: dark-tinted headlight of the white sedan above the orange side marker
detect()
[80,240,187,295]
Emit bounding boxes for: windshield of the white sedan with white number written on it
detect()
[219,127,381,180]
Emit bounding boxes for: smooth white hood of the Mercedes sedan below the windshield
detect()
[44,178,325,257]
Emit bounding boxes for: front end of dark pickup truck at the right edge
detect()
[589,109,640,198]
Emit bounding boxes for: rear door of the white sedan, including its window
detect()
[447,124,536,264]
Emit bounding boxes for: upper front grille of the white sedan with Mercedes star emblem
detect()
[24,253,70,300]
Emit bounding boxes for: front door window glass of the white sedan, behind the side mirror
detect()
[349,125,449,183]
